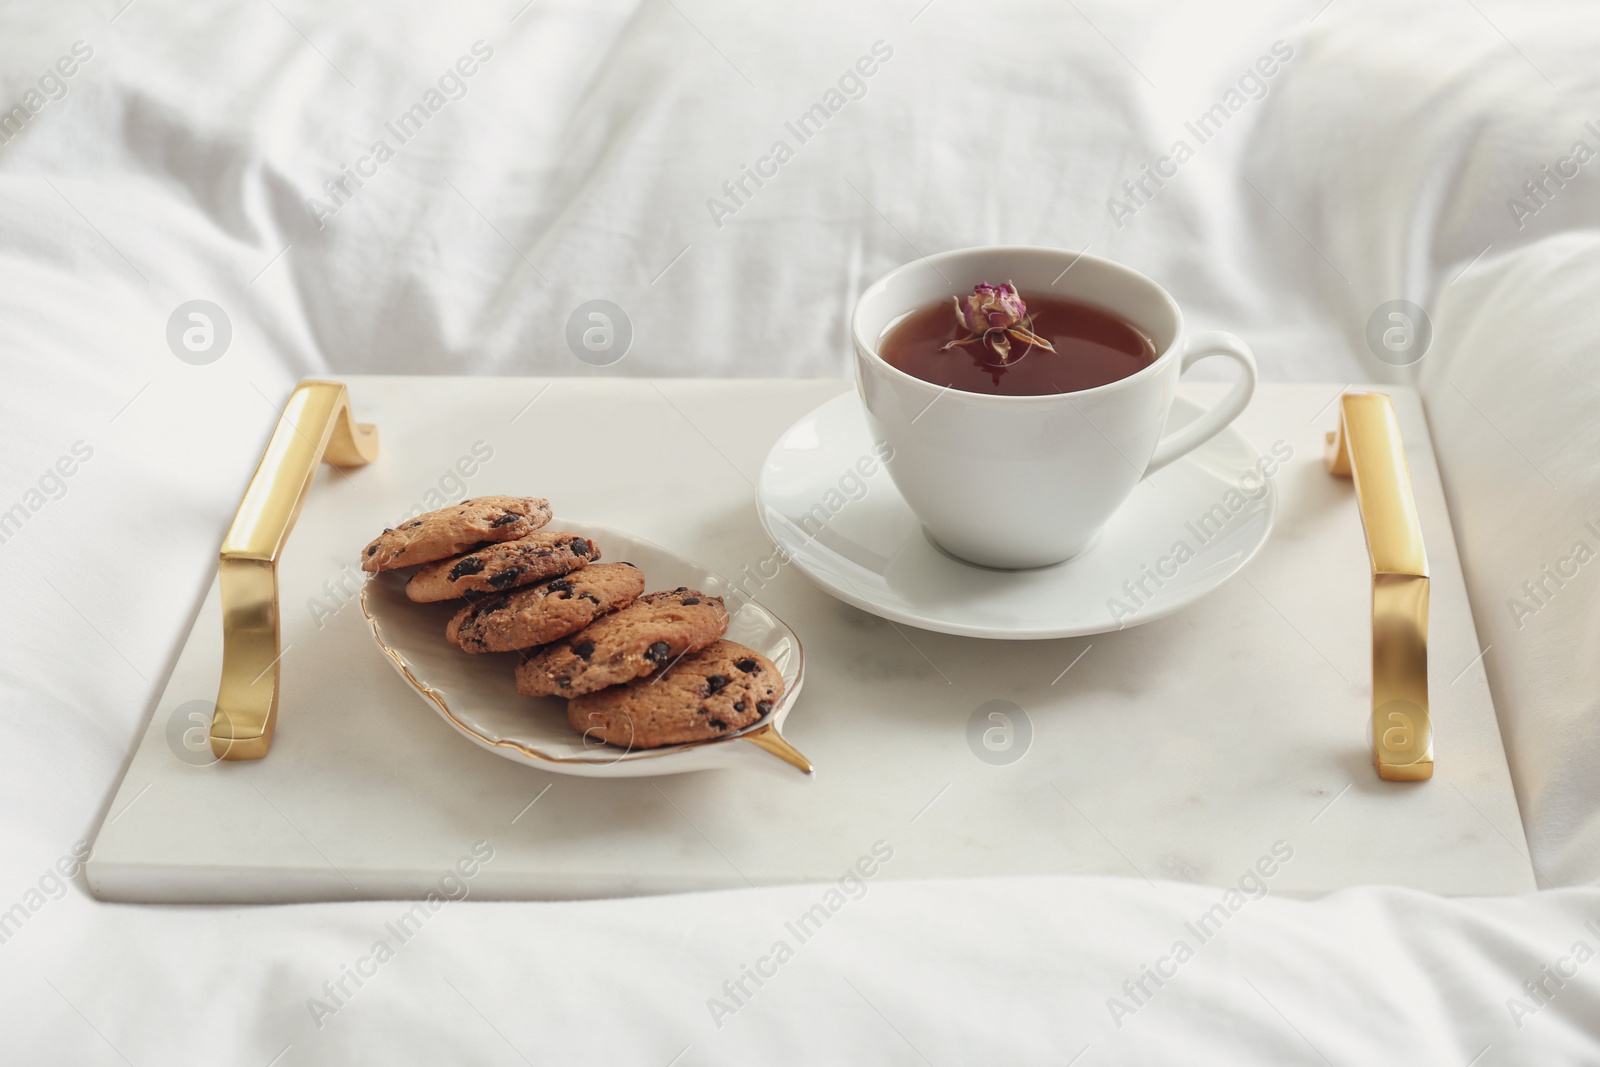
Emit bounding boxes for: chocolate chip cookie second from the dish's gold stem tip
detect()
[517,585,728,696]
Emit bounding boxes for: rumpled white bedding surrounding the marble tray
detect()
[0,0,1600,1067]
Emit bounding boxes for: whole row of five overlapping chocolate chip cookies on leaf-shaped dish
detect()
[362,496,784,749]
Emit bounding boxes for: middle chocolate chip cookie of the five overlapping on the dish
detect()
[445,563,645,653]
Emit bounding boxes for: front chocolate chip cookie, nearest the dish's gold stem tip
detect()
[566,641,784,749]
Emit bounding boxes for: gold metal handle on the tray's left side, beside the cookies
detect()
[211,381,378,760]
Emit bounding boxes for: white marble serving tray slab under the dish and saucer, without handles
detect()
[88,378,1534,902]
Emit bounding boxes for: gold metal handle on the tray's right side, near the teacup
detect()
[1326,394,1434,782]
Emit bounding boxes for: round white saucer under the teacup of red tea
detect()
[757,392,1277,640]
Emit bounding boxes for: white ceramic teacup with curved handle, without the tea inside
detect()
[851,246,1256,569]
